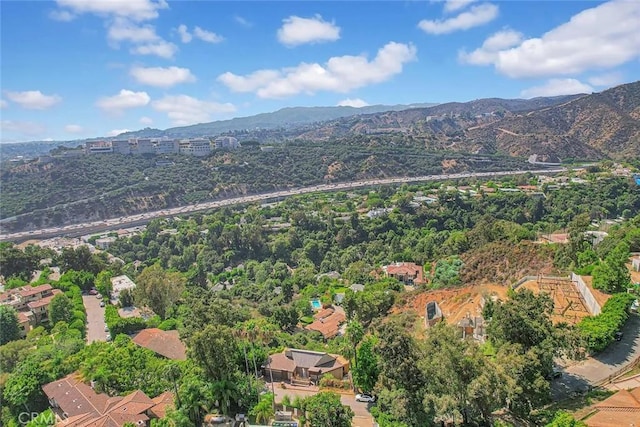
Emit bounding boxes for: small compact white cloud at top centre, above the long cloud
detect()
[278,15,340,47]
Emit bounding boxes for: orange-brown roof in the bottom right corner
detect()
[584,388,640,427]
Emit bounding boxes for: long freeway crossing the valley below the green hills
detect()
[0,167,568,242]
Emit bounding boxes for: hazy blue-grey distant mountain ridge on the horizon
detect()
[119,103,436,138]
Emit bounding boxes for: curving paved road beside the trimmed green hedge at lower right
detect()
[551,315,640,399]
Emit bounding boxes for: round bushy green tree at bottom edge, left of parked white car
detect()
[304,391,354,427]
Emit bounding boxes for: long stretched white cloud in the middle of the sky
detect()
[218,42,416,98]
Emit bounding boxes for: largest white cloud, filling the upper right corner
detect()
[462,0,640,78]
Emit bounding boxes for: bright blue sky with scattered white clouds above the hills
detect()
[0,0,640,142]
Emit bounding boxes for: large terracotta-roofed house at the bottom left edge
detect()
[42,373,173,427]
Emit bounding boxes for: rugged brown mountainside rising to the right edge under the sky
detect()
[297,81,640,159]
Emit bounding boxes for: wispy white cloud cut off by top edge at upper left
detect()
[56,0,169,21]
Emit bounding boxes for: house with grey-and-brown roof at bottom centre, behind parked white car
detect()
[263,349,349,383]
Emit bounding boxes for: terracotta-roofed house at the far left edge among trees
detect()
[0,284,62,337]
